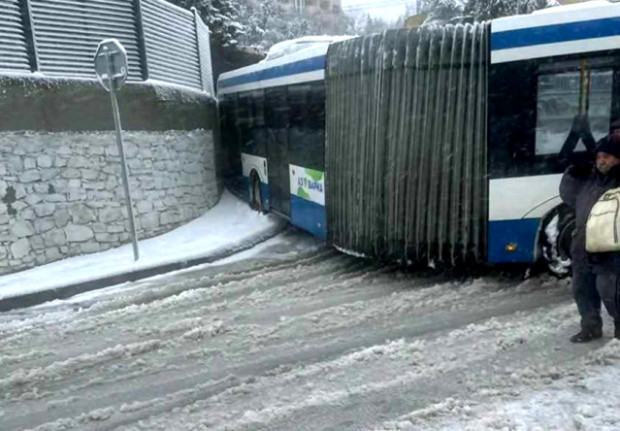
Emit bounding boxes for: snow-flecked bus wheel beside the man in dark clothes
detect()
[540,206,575,277]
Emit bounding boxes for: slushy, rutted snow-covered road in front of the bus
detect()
[0,232,620,431]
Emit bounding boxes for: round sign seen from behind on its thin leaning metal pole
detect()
[95,39,140,261]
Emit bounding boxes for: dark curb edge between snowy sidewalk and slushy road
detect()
[0,221,287,312]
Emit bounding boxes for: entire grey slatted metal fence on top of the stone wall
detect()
[0,0,214,95]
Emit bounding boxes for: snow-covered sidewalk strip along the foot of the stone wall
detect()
[0,191,281,299]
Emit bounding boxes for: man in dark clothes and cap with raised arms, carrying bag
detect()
[560,133,620,343]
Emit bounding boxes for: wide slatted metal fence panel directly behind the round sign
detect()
[30,0,142,81]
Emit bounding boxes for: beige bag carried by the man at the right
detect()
[586,188,620,253]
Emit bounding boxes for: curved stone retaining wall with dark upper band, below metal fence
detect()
[0,78,221,274]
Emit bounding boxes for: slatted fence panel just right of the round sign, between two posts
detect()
[142,0,203,89]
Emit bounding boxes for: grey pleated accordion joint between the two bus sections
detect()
[326,23,489,265]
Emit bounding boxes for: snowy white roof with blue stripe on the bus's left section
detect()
[217,36,348,95]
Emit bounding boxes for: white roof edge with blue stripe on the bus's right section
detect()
[491,1,620,63]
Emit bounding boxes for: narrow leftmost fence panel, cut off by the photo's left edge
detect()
[0,0,30,72]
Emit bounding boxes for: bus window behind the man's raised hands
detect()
[536,69,613,156]
